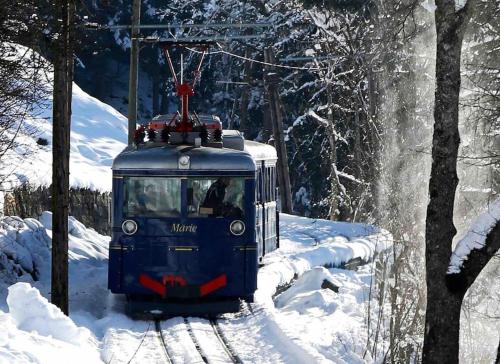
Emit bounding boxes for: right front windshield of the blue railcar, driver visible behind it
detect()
[187,177,245,218]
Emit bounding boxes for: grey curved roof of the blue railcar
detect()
[112,131,277,171]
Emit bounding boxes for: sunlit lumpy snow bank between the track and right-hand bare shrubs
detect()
[274,264,378,364]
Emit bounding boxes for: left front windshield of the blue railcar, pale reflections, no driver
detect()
[123,177,181,217]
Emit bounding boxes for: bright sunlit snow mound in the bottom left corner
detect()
[0,283,101,363]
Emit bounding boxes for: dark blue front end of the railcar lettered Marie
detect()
[108,146,258,315]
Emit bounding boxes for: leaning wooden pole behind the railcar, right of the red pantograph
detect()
[264,48,293,214]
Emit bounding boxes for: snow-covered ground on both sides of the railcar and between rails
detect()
[0,213,391,363]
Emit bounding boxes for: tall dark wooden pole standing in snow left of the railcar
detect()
[51,0,75,315]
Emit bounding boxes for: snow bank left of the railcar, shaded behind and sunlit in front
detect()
[0,212,109,364]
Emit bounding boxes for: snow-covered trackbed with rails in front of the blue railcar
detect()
[103,305,318,364]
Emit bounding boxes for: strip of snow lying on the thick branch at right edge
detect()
[447,198,500,274]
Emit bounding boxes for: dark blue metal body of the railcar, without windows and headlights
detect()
[108,141,276,314]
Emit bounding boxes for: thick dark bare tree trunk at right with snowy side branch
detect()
[422,0,473,364]
